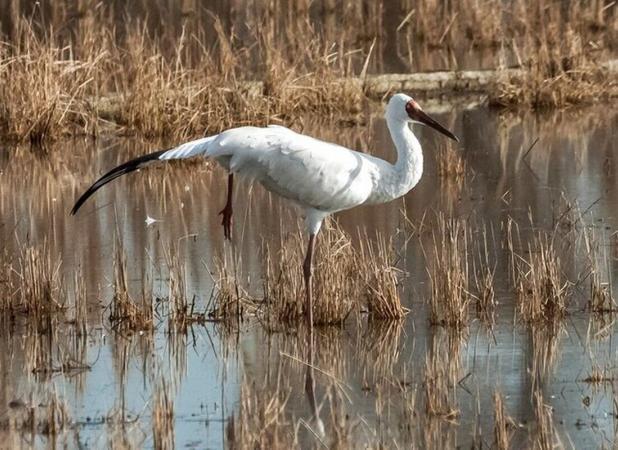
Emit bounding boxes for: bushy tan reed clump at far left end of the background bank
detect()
[0,19,105,143]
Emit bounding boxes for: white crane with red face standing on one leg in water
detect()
[71,94,458,329]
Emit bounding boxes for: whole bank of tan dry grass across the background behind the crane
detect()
[0,0,618,142]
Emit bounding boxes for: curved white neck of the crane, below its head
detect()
[371,115,423,203]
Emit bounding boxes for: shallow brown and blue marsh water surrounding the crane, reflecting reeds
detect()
[0,100,618,448]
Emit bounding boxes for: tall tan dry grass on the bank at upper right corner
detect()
[490,1,618,108]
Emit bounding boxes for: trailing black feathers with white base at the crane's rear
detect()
[71,136,216,215]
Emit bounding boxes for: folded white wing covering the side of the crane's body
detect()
[207,126,374,211]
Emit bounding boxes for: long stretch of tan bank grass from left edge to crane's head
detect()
[0,7,363,142]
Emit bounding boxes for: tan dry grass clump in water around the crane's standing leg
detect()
[263,221,406,325]
